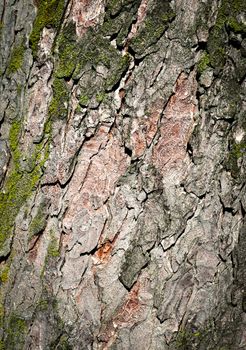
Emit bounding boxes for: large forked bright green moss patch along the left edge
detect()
[0,117,49,255]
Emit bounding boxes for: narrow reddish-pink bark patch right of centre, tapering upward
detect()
[152,73,197,173]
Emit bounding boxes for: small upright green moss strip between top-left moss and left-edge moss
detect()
[49,78,69,119]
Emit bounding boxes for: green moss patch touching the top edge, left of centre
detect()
[30,0,66,56]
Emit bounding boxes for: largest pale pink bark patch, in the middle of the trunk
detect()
[63,127,129,254]
